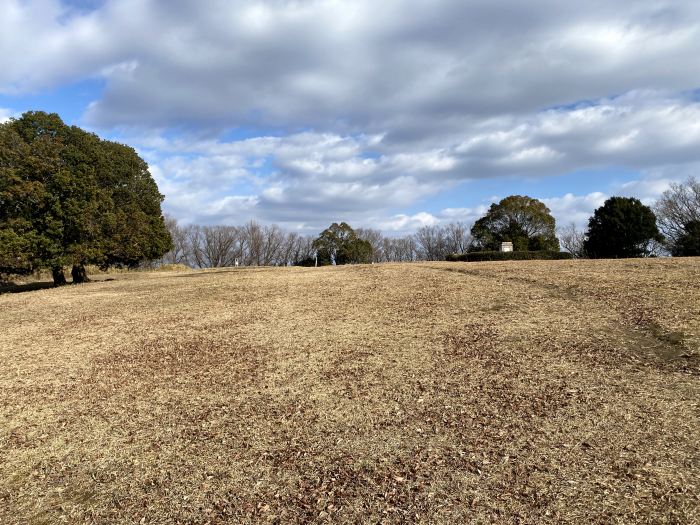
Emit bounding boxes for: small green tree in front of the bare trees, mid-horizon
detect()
[313,222,372,266]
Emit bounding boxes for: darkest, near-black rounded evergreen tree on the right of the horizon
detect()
[584,197,663,258]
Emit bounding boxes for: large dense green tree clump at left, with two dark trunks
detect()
[0,112,171,284]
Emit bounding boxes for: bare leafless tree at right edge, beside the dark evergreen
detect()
[654,177,700,253]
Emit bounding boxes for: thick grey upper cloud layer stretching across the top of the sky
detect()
[0,0,700,130]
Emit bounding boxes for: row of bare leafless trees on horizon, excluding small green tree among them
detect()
[162,218,471,268]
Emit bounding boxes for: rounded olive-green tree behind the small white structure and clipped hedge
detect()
[471,195,559,251]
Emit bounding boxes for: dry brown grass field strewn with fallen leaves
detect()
[0,259,700,524]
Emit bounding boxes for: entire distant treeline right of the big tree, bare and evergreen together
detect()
[163,177,700,268]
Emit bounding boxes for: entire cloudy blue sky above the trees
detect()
[0,0,700,235]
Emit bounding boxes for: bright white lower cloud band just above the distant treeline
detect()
[132,93,700,230]
